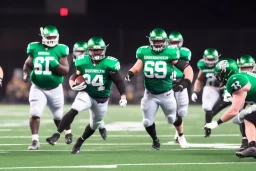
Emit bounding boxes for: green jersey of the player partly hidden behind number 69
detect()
[173,47,192,81]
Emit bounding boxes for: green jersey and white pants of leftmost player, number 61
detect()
[27,42,69,120]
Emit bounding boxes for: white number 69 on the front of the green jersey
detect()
[144,61,167,78]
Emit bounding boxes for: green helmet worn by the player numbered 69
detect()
[148,28,168,52]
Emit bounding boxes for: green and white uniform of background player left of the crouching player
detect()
[197,59,220,111]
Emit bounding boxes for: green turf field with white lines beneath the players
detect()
[0,105,256,171]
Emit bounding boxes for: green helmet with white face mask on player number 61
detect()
[40,26,59,47]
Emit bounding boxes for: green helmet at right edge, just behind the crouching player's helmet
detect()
[237,55,255,72]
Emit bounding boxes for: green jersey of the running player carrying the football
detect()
[75,55,120,98]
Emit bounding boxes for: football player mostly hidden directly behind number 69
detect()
[169,31,192,148]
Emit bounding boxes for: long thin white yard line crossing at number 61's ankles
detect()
[0,134,240,139]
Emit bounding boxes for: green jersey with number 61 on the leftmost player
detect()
[27,42,69,88]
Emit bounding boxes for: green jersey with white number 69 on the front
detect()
[136,46,179,94]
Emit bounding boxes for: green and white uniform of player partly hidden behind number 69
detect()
[173,47,192,117]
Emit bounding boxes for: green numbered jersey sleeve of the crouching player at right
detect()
[226,74,249,94]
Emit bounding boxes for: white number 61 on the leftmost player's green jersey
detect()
[34,56,54,75]
